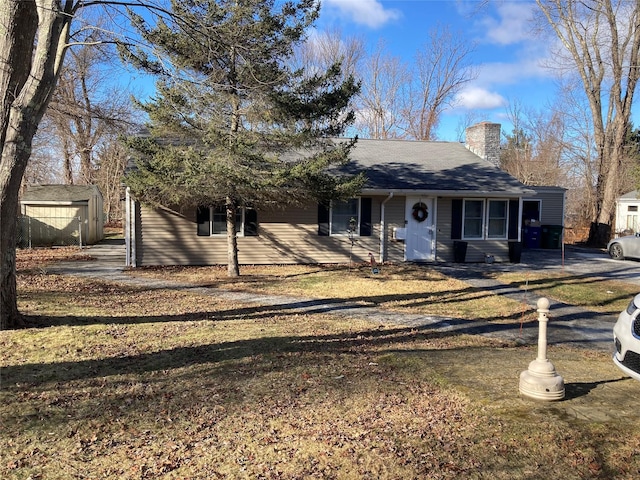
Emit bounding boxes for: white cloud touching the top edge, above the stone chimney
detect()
[478,2,536,45]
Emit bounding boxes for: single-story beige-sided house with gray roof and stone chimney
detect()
[125,122,564,266]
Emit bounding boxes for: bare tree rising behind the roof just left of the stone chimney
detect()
[403,27,476,140]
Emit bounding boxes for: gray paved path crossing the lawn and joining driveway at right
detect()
[49,241,640,351]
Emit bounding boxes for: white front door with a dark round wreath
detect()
[405,197,435,261]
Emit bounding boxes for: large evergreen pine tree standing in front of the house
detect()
[123,0,364,276]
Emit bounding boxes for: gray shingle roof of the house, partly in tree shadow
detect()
[342,139,532,195]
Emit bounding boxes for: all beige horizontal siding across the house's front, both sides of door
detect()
[136,191,532,266]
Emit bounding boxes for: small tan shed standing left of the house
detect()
[19,185,104,247]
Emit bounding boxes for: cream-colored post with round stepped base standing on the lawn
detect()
[520,297,564,401]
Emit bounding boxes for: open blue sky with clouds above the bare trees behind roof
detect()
[318,0,556,140]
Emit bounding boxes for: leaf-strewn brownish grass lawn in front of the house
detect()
[0,252,640,479]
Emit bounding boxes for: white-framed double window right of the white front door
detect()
[462,199,509,240]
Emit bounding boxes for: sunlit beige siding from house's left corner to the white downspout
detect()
[137,199,380,266]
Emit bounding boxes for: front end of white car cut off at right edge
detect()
[613,293,640,381]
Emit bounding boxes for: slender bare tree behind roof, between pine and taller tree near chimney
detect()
[356,42,409,138]
